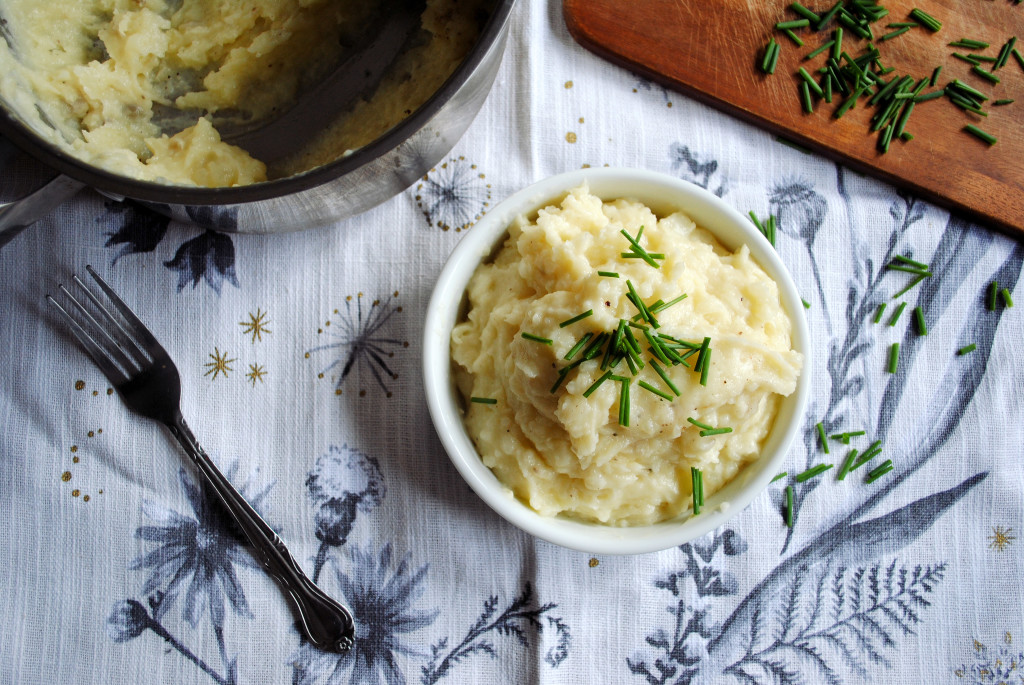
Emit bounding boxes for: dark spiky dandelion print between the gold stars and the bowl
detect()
[306,293,409,397]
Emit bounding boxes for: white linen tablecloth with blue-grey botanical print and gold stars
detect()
[0,1,1024,685]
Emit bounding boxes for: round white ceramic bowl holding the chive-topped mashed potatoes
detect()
[423,168,810,554]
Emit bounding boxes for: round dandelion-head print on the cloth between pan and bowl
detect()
[416,157,490,231]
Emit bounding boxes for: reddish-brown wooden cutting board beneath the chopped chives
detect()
[562,0,1024,237]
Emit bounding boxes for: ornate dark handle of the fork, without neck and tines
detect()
[167,414,355,651]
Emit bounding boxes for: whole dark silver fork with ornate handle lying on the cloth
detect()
[46,266,355,651]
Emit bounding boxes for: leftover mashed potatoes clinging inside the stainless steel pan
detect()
[0,0,484,186]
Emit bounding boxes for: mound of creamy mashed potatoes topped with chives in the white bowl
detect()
[452,187,803,525]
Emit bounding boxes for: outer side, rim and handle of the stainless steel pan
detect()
[0,0,515,247]
